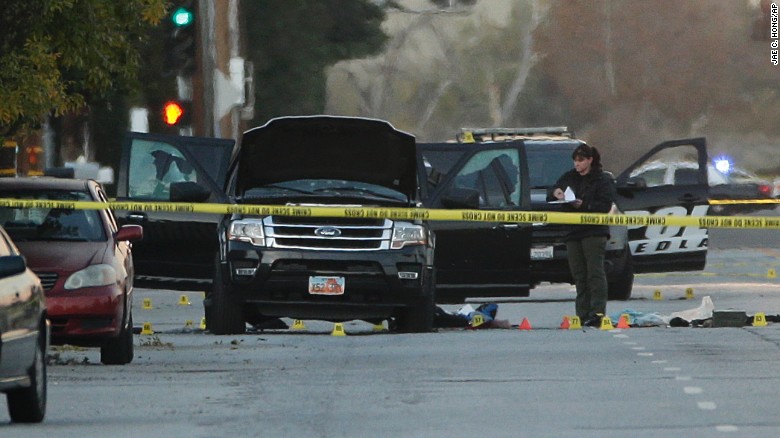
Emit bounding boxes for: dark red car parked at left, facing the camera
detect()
[0,177,143,365]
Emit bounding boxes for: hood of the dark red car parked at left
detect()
[16,241,107,272]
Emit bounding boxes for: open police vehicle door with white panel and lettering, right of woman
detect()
[616,138,709,273]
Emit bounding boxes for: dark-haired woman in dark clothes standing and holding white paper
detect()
[547,144,615,327]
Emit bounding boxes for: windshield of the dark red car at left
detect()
[0,190,106,242]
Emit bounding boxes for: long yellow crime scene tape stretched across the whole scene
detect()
[0,198,780,229]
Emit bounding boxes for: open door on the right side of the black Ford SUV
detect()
[417,142,531,303]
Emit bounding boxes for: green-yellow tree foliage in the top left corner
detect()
[0,0,166,137]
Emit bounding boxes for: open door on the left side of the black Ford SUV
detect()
[116,132,235,291]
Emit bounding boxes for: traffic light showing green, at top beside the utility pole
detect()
[166,0,197,76]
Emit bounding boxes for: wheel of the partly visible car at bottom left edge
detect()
[6,332,47,423]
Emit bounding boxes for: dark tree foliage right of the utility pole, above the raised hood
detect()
[241,0,387,123]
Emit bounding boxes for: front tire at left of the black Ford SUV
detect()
[203,266,246,335]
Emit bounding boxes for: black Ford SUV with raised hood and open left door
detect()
[118,116,435,334]
